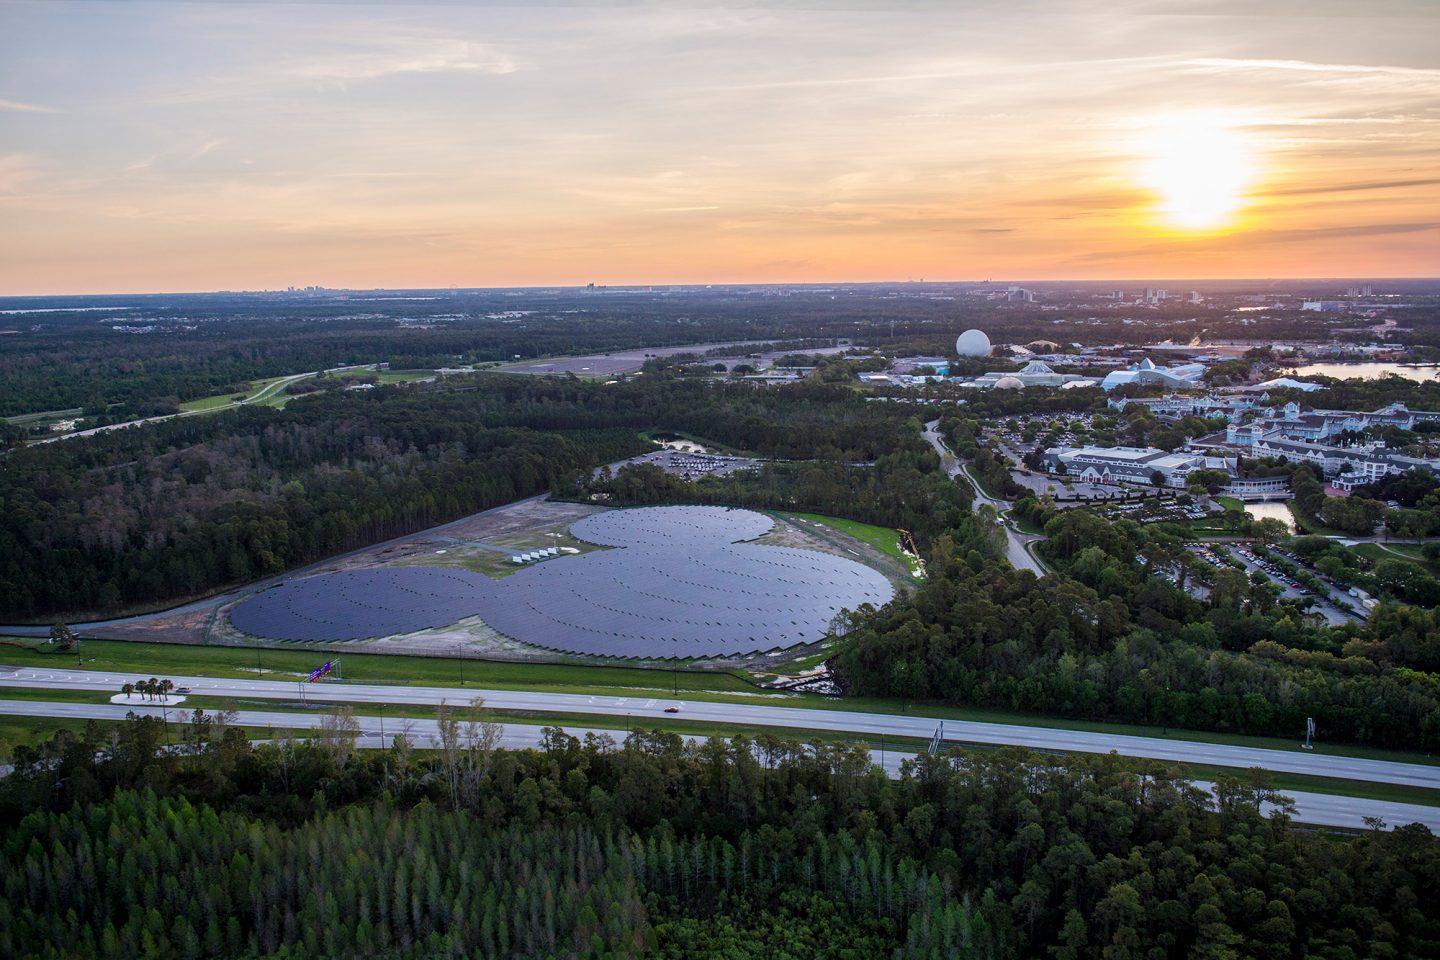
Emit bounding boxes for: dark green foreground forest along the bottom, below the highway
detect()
[0,716,1440,960]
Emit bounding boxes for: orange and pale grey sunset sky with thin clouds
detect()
[0,0,1440,295]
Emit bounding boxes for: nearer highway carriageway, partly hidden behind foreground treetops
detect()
[0,701,1440,832]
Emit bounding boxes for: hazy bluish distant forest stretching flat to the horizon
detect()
[0,284,1440,420]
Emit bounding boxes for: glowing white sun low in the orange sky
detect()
[1142,117,1254,230]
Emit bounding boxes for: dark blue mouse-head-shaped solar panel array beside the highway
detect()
[230,507,893,658]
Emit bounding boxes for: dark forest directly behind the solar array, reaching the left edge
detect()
[0,374,943,622]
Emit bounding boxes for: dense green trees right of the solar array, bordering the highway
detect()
[835,510,1440,751]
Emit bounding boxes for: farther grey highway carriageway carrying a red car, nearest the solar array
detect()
[0,666,1440,789]
